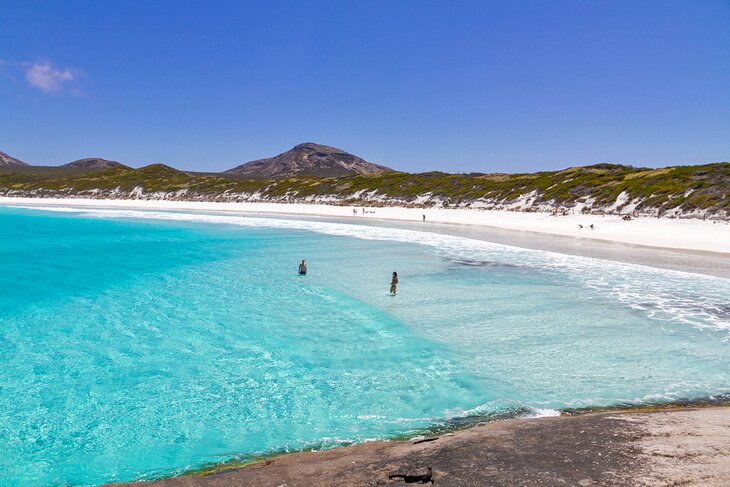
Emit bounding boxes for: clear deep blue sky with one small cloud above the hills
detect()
[0,0,730,172]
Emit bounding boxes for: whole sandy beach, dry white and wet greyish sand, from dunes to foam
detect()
[5,197,730,278]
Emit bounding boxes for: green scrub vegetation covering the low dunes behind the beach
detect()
[0,162,730,217]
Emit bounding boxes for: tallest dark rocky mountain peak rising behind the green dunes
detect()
[225,143,392,179]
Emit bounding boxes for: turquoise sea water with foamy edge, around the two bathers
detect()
[0,207,730,485]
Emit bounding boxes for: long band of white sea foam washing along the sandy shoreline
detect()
[14,206,730,340]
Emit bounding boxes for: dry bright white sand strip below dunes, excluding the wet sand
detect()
[0,197,730,254]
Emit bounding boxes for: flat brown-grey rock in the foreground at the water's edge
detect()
[114,408,730,487]
